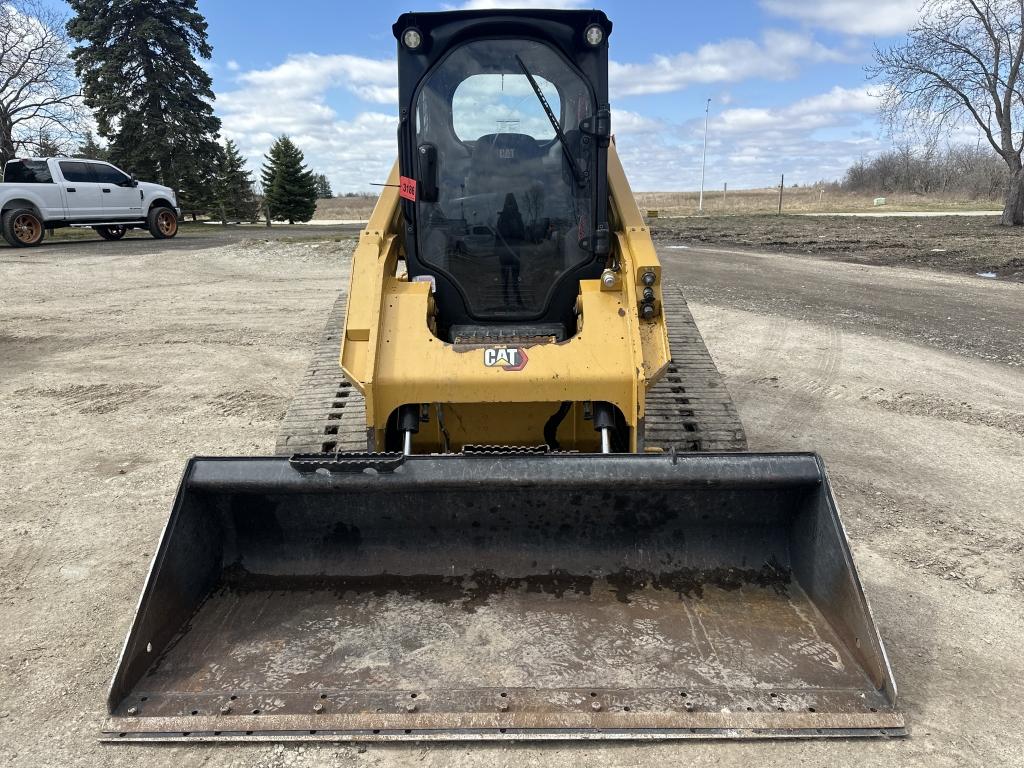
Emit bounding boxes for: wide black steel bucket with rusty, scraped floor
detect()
[103,454,904,741]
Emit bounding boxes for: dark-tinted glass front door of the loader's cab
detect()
[416,40,594,319]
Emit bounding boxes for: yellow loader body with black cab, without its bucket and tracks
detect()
[342,11,669,453]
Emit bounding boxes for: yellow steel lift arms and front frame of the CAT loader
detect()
[341,142,670,453]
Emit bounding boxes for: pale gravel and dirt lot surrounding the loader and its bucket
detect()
[0,238,1024,768]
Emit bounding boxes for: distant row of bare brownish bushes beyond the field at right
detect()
[842,144,1010,200]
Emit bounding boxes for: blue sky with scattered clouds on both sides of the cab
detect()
[68,0,937,191]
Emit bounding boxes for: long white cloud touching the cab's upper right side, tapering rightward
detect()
[608,30,845,97]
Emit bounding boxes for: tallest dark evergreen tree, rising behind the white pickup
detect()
[68,0,220,217]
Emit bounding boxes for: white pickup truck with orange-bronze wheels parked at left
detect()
[0,158,181,248]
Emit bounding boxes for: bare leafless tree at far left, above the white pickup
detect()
[0,0,85,166]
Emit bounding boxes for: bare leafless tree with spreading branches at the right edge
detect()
[868,0,1024,224]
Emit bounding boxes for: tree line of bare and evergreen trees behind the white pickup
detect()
[0,0,333,222]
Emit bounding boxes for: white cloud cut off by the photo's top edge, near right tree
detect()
[761,0,922,36]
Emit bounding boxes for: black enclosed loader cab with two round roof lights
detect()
[394,11,611,343]
